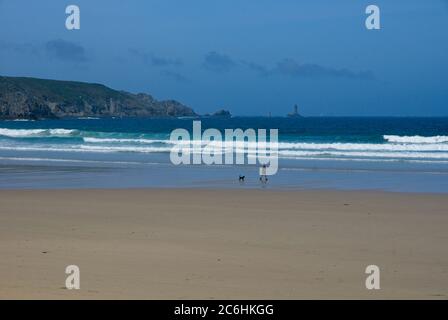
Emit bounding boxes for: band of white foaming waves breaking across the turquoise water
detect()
[0,128,448,161]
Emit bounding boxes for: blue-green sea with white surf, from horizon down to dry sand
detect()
[0,117,448,193]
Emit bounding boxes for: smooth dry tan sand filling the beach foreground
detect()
[0,189,448,299]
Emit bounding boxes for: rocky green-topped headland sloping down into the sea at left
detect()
[0,77,196,119]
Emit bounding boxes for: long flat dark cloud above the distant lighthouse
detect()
[271,59,374,79]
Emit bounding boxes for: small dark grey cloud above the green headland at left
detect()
[45,39,88,62]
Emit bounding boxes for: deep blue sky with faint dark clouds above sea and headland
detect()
[0,0,448,116]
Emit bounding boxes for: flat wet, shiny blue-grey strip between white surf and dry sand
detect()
[0,155,448,194]
